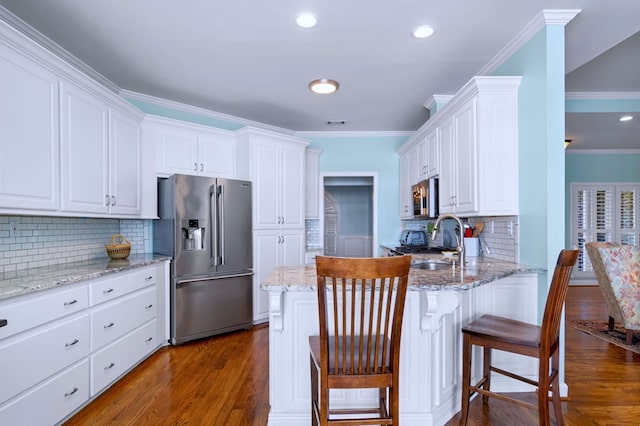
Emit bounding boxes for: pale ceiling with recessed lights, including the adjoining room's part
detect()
[0,0,640,149]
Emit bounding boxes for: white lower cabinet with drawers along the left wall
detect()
[0,263,168,425]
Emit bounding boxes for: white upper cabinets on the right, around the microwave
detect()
[398,77,521,216]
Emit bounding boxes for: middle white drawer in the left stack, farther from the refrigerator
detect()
[0,314,90,403]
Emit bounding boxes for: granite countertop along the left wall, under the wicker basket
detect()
[0,254,171,300]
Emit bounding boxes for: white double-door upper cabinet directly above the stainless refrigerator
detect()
[152,117,235,178]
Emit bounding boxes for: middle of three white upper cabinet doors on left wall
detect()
[60,82,111,214]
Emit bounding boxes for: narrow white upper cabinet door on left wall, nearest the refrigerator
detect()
[109,109,142,215]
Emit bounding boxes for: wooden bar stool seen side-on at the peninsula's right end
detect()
[460,250,578,425]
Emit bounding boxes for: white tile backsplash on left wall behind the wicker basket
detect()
[0,215,151,274]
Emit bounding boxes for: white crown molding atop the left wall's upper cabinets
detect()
[0,6,120,94]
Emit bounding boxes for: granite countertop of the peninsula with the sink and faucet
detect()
[261,254,546,291]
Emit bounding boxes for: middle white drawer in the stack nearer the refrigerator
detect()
[91,286,157,352]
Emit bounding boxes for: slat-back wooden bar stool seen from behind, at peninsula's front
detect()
[309,256,411,425]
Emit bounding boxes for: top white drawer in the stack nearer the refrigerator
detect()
[89,267,158,306]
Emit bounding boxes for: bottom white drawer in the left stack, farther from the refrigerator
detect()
[0,359,89,426]
